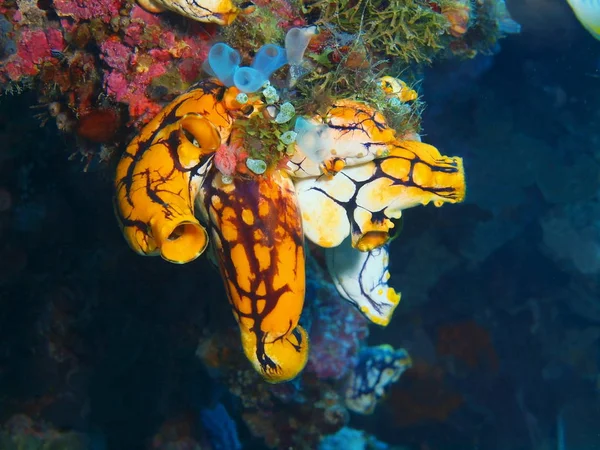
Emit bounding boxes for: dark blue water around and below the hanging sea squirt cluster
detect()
[0,0,600,450]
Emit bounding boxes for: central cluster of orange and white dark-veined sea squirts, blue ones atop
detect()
[115,24,465,382]
